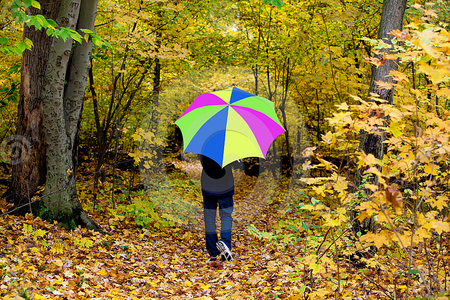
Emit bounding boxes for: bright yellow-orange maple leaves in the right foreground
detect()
[294,5,450,296]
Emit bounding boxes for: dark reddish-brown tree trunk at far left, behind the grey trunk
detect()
[7,0,61,211]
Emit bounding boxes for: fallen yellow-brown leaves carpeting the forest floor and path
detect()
[0,158,446,299]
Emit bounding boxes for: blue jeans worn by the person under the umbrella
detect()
[203,195,233,257]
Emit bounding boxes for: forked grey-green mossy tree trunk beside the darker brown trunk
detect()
[41,0,99,230]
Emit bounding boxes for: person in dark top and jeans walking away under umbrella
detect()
[199,155,234,261]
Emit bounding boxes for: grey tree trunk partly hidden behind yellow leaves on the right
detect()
[351,0,407,234]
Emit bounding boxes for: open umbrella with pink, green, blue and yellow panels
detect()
[175,87,285,167]
